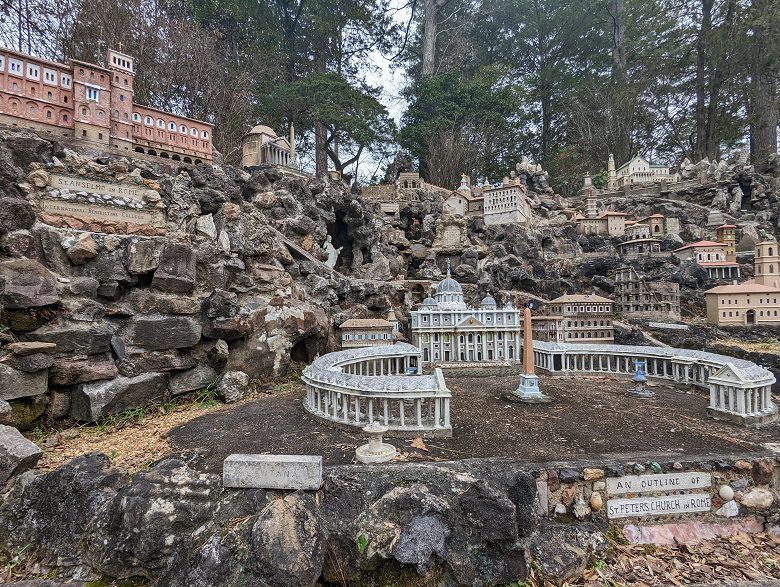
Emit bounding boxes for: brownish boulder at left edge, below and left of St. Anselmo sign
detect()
[0,259,60,309]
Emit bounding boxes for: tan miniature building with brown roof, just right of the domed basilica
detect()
[533,294,615,344]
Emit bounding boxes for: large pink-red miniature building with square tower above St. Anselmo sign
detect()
[0,49,213,163]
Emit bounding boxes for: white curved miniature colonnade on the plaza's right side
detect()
[533,340,777,425]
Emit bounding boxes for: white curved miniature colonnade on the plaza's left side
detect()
[301,343,452,436]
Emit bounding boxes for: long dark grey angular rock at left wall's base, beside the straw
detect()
[70,373,168,422]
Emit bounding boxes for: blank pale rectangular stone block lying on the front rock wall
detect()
[222,454,322,490]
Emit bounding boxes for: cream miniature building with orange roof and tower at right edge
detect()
[704,240,780,326]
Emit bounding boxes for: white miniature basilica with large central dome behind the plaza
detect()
[411,267,522,363]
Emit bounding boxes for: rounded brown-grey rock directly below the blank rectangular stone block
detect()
[252,493,323,587]
